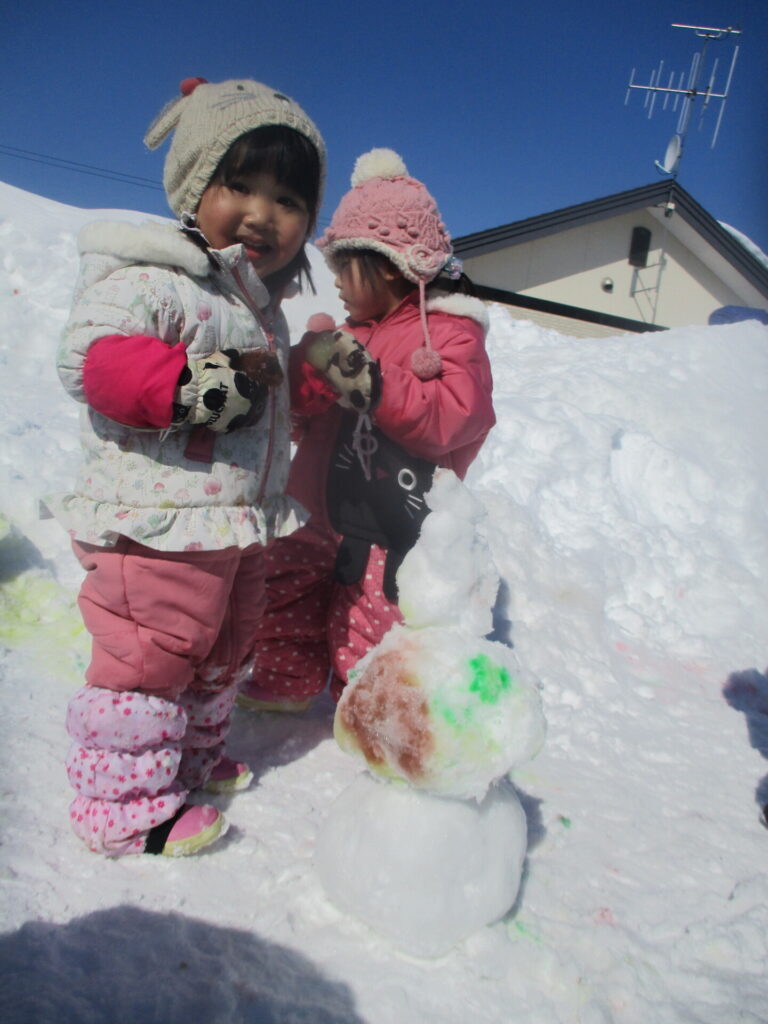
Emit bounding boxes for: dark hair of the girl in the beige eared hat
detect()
[211,125,321,293]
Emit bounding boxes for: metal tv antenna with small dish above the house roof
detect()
[624,25,741,177]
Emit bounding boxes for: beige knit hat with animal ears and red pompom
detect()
[144,78,326,217]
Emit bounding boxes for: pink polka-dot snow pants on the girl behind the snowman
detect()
[246,517,402,700]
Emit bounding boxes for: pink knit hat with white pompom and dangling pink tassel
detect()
[316,150,458,380]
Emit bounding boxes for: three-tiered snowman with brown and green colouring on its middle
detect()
[315,469,545,957]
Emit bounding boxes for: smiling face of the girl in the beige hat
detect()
[198,171,309,280]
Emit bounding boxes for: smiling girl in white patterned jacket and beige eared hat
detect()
[49,79,325,856]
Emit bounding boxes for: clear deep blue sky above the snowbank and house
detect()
[0,0,768,251]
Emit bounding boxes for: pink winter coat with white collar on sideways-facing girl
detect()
[288,292,496,519]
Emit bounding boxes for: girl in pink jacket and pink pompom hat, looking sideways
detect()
[238,150,495,711]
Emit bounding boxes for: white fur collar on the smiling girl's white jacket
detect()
[78,220,211,278]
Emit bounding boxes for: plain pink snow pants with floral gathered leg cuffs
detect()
[67,538,265,857]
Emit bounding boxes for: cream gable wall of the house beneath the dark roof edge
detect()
[464,210,754,327]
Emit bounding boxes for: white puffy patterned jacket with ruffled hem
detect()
[46,222,304,551]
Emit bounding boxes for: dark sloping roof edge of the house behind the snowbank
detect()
[454,178,768,298]
